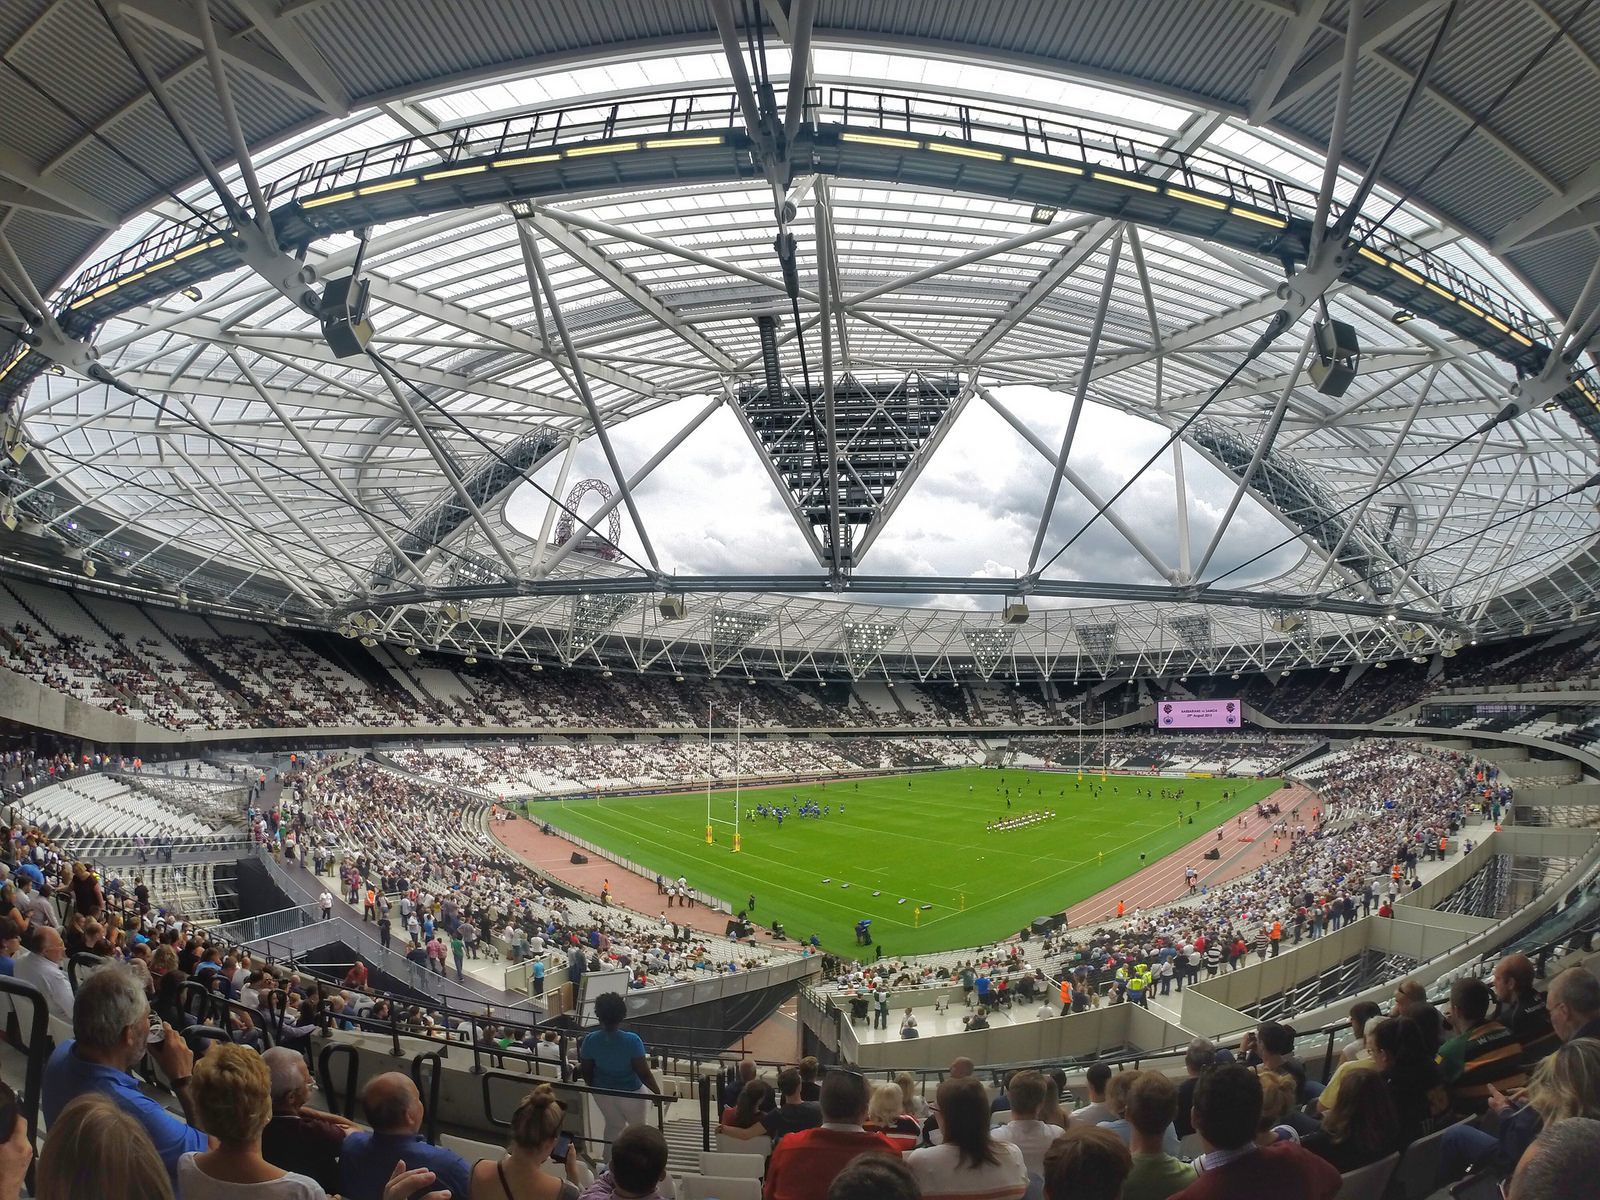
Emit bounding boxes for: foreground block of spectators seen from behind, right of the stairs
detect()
[704,979,1600,1200]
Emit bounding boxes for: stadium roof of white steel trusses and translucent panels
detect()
[0,0,1600,675]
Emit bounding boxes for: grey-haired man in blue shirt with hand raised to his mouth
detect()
[43,965,211,1173]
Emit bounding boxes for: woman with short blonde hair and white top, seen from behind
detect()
[178,1042,323,1200]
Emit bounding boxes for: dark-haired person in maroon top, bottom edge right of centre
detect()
[1173,1064,1342,1200]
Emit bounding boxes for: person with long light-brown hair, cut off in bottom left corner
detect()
[34,1091,173,1200]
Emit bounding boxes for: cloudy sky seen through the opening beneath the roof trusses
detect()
[506,386,1299,610]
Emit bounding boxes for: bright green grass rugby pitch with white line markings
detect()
[530,768,1280,957]
